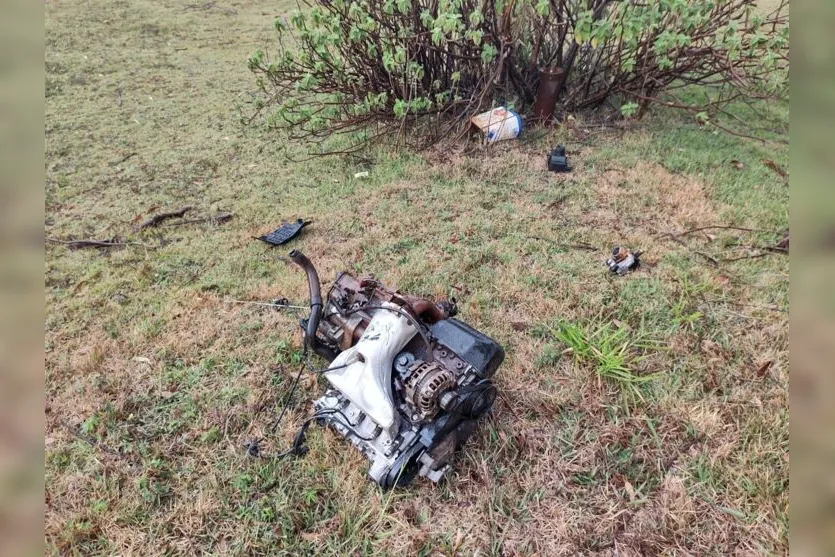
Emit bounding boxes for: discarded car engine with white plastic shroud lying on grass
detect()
[290,250,504,488]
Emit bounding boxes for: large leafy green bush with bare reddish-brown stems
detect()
[249,0,789,151]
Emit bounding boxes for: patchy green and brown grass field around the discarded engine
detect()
[45,0,789,556]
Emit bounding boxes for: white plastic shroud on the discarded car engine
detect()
[325,302,417,434]
